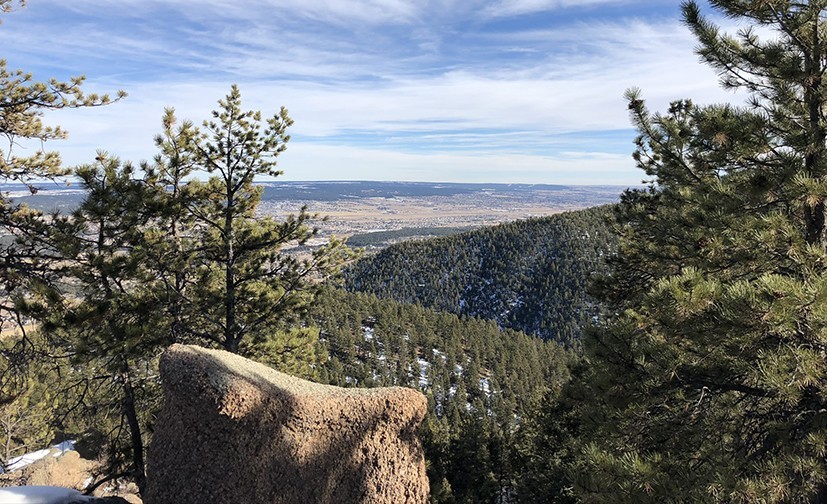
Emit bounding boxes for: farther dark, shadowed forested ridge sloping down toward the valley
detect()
[345,206,615,344]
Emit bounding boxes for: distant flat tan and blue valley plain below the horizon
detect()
[259,182,625,241]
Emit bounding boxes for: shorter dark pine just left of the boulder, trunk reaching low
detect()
[27,153,162,490]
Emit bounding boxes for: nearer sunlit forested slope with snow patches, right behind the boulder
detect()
[311,290,572,502]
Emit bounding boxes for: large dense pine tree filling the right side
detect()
[573,0,827,502]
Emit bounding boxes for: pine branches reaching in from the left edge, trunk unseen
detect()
[0,0,126,402]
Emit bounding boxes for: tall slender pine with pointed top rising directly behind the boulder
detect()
[154,86,350,358]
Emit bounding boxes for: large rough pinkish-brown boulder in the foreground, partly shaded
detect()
[144,345,428,504]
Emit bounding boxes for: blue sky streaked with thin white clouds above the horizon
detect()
[0,0,752,185]
